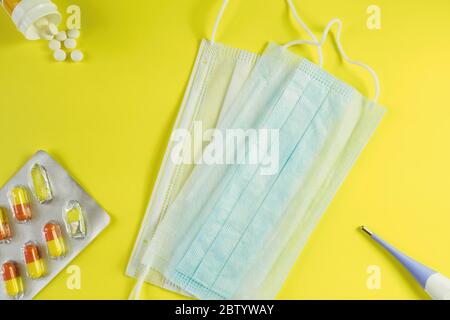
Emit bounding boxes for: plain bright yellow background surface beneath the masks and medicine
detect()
[0,0,450,299]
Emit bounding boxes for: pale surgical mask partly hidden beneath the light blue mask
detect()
[127,11,258,292]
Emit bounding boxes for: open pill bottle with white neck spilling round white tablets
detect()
[0,0,61,40]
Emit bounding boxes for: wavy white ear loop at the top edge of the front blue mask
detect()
[283,18,380,102]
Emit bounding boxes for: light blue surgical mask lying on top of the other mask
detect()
[131,0,384,299]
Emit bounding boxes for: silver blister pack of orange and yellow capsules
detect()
[0,151,110,300]
